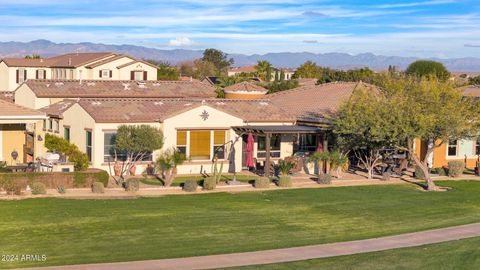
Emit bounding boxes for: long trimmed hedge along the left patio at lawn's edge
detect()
[0,169,109,189]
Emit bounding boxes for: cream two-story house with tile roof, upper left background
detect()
[0,53,157,91]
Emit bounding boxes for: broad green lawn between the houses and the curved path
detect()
[0,181,480,268]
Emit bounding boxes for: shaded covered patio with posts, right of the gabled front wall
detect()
[232,125,328,176]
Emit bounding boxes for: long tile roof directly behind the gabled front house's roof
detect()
[25,80,216,98]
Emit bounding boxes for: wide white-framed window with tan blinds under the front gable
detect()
[176,129,227,161]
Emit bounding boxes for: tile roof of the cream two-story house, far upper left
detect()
[2,53,115,68]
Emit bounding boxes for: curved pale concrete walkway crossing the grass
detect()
[23,223,480,270]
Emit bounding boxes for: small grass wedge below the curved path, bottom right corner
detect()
[228,237,480,270]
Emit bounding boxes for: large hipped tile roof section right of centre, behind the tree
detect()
[265,82,376,122]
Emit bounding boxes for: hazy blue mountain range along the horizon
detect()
[0,40,480,72]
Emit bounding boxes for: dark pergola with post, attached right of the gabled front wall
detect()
[232,125,326,176]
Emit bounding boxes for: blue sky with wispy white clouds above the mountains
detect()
[0,0,480,58]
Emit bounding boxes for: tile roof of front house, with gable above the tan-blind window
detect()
[71,98,295,123]
